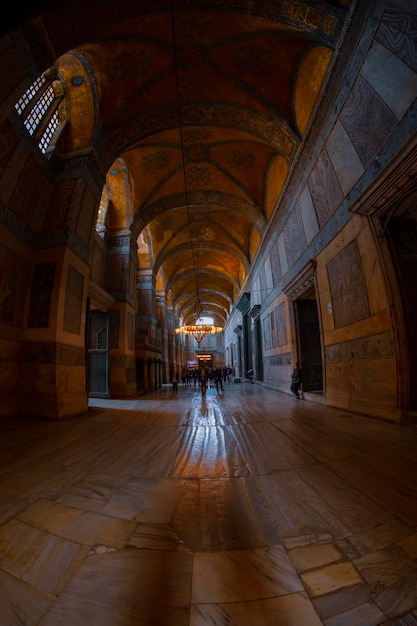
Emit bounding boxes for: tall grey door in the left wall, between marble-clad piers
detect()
[87,311,110,397]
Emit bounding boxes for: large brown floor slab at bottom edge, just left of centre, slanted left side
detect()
[40,548,193,626]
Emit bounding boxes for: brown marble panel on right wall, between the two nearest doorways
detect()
[327,241,369,328]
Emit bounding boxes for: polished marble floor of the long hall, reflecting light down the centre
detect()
[0,383,417,626]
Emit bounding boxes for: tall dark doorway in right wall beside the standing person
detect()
[295,298,323,393]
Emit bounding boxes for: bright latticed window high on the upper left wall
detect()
[15,74,64,154]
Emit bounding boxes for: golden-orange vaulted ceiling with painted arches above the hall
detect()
[20,0,349,325]
